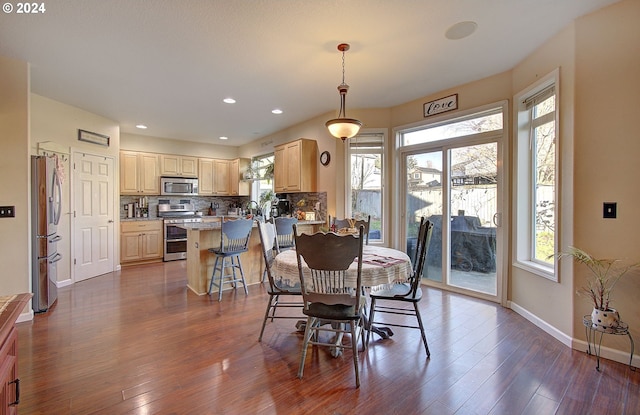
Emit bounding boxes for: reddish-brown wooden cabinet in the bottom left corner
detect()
[0,294,32,415]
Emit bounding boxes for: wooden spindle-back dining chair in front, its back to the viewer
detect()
[294,225,366,387]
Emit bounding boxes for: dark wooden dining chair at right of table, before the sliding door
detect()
[367,218,433,358]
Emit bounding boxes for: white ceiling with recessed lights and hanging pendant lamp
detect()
[0,0,617,145]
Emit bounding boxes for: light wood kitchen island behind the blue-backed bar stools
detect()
[180,217,324,295]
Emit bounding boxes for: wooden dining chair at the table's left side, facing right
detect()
[258,222,303,341]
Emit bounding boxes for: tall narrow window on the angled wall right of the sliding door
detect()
[514,71,558,280]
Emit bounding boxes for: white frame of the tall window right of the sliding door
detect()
[513,69,561,282]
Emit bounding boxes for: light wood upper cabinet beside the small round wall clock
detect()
[273,138,318,193]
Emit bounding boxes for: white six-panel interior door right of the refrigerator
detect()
[72,153,115,282]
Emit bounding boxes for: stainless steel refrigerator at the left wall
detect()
[31,156,62,313]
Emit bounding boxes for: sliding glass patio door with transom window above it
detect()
[400,105,503,301]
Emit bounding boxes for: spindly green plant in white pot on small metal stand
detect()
[558,246,640,328]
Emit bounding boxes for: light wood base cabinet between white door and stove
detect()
[120,220,164,264]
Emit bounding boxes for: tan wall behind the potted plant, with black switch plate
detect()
[573,0,640,358]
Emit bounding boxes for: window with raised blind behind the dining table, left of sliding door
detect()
[345,133,384,243]
